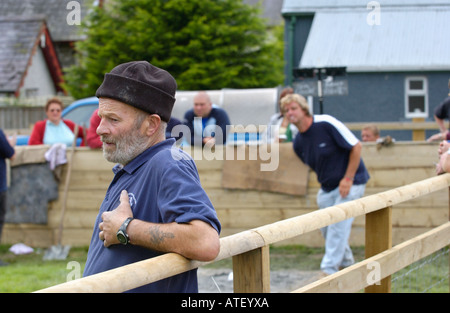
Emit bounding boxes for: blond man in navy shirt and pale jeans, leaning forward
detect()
[281,94,369,274]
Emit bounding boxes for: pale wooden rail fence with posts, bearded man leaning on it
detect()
[38,174,450,292]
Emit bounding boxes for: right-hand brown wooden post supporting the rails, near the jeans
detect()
[365,206,392,293]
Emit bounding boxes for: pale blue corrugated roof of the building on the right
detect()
[288,1,450,72]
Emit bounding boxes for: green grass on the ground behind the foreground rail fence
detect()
[0,245,449,293]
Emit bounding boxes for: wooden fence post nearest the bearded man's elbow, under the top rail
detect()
[233,246,270,293]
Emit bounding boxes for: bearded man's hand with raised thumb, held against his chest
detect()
[98,190,133,247]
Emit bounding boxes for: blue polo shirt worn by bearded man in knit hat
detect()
[83,138,221,292]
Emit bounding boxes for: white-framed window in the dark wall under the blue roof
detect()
[405,77,428,118]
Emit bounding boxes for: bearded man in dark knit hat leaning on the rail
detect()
[84,61,221,292]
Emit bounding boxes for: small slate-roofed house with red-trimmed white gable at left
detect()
[0,16,63,98]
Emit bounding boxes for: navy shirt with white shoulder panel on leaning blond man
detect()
[293,114,369,192]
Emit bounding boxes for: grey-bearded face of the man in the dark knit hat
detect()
[97,98,149,165]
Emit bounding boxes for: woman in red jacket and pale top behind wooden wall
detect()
[28,98,84,147]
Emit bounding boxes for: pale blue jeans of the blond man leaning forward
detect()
[317,184,366,274]
